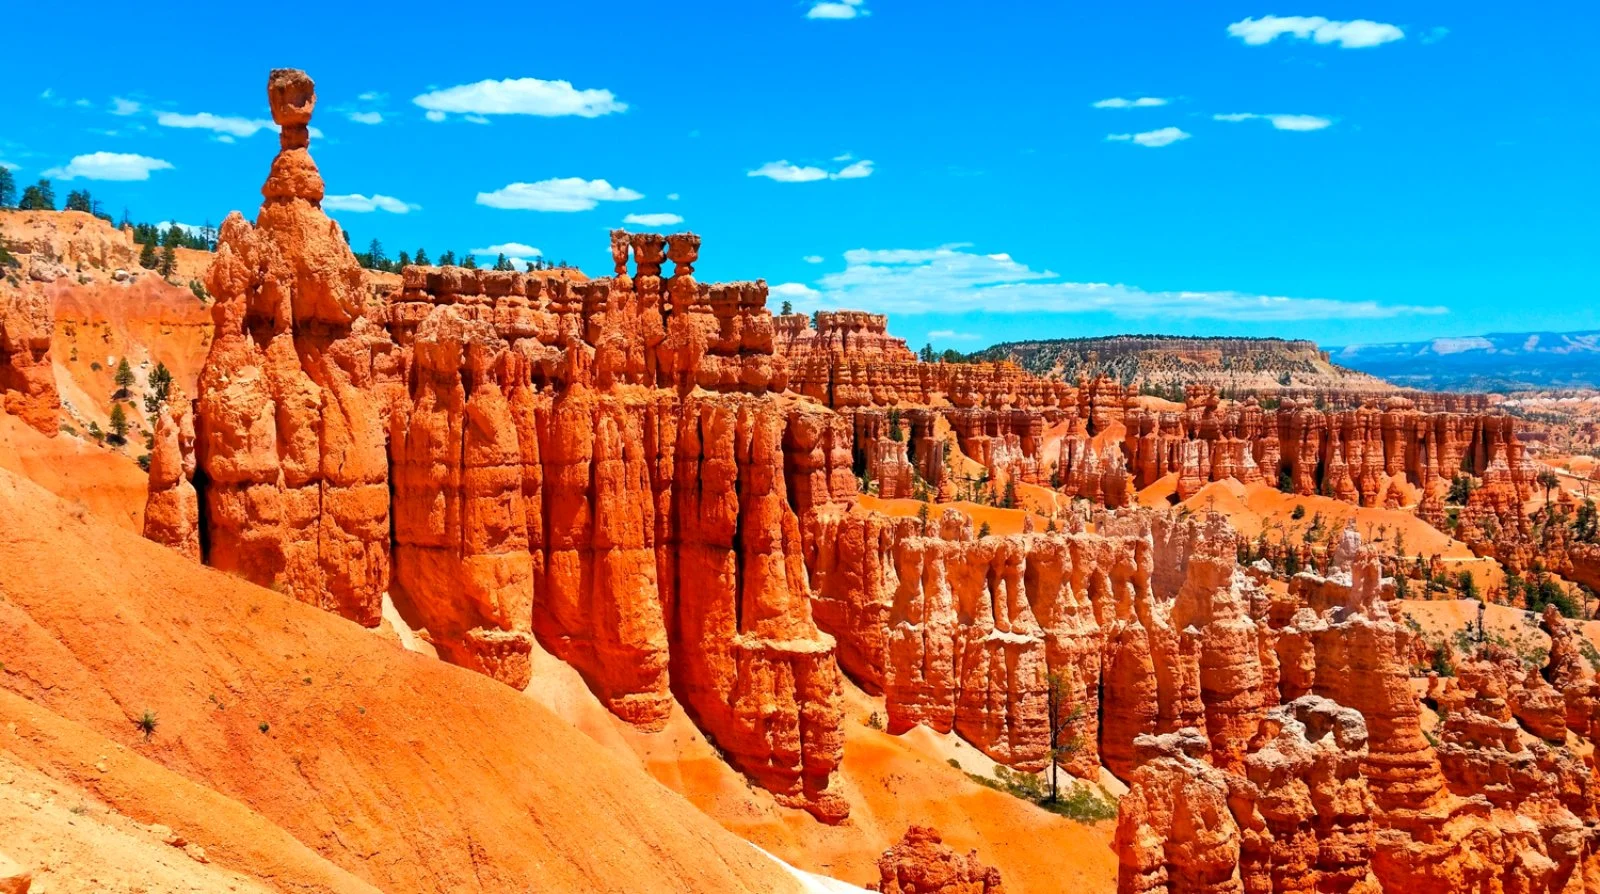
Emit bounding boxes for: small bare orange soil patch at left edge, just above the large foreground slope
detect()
[0,413,146,534]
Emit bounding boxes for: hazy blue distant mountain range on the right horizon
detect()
[1328,331,1600,392]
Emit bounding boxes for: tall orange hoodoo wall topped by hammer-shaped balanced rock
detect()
[147,70,854,820]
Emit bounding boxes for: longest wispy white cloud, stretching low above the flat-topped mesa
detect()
[771,245,1446,321]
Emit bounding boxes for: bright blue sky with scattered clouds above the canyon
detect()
[0,0,1600,350]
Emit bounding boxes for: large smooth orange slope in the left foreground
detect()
[0,472,800,892]
